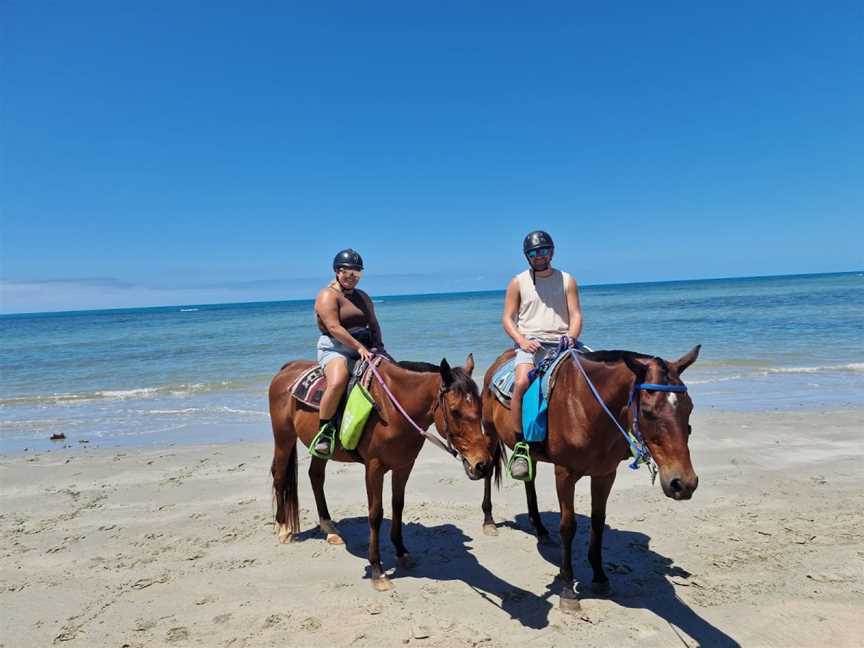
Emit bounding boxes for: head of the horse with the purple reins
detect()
[434,353,495,479]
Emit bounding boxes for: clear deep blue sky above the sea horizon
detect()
[0,0,864,312]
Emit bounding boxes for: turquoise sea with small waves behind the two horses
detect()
[0,272,864,451]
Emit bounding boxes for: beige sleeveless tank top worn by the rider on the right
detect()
[516,270,570,342]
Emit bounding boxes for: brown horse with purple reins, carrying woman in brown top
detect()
[270,354,500,591]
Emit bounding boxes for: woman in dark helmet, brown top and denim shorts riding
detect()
[309,248,384,459]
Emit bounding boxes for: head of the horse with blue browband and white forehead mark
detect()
[625,345,700,500]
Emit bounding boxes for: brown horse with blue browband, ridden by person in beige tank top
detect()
[482,346,700,611]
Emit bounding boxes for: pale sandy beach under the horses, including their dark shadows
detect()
[0,410,864,648]
